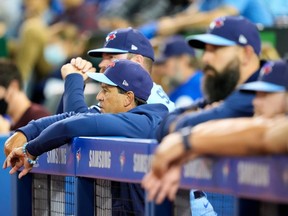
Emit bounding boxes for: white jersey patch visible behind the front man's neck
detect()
[147,83,175,112]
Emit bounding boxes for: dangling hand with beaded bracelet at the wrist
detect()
[3,147,33,179]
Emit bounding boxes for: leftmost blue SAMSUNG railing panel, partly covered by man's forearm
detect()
[31,144,75,176]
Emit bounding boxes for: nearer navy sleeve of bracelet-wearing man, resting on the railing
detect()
[27,113,154,156]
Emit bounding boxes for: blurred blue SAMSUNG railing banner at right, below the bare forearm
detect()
[181,155,288,202]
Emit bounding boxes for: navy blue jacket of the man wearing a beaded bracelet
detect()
[17,104,168,156]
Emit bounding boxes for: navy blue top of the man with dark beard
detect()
[157,61,264,141]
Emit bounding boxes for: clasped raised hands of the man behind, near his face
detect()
[61,57,96,81]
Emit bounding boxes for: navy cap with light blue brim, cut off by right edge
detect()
[240,60,288,93]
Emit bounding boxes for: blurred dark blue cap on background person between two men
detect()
[156,35,195,62]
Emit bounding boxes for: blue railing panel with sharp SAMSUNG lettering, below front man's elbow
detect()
[75,137,157,182]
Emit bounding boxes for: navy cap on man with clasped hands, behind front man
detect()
[88,27,154,61]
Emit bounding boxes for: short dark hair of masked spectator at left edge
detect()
[0,58,23,89]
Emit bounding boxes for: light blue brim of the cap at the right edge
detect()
[240,81,286,92]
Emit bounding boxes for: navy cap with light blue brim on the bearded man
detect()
[186,16,261,55]
